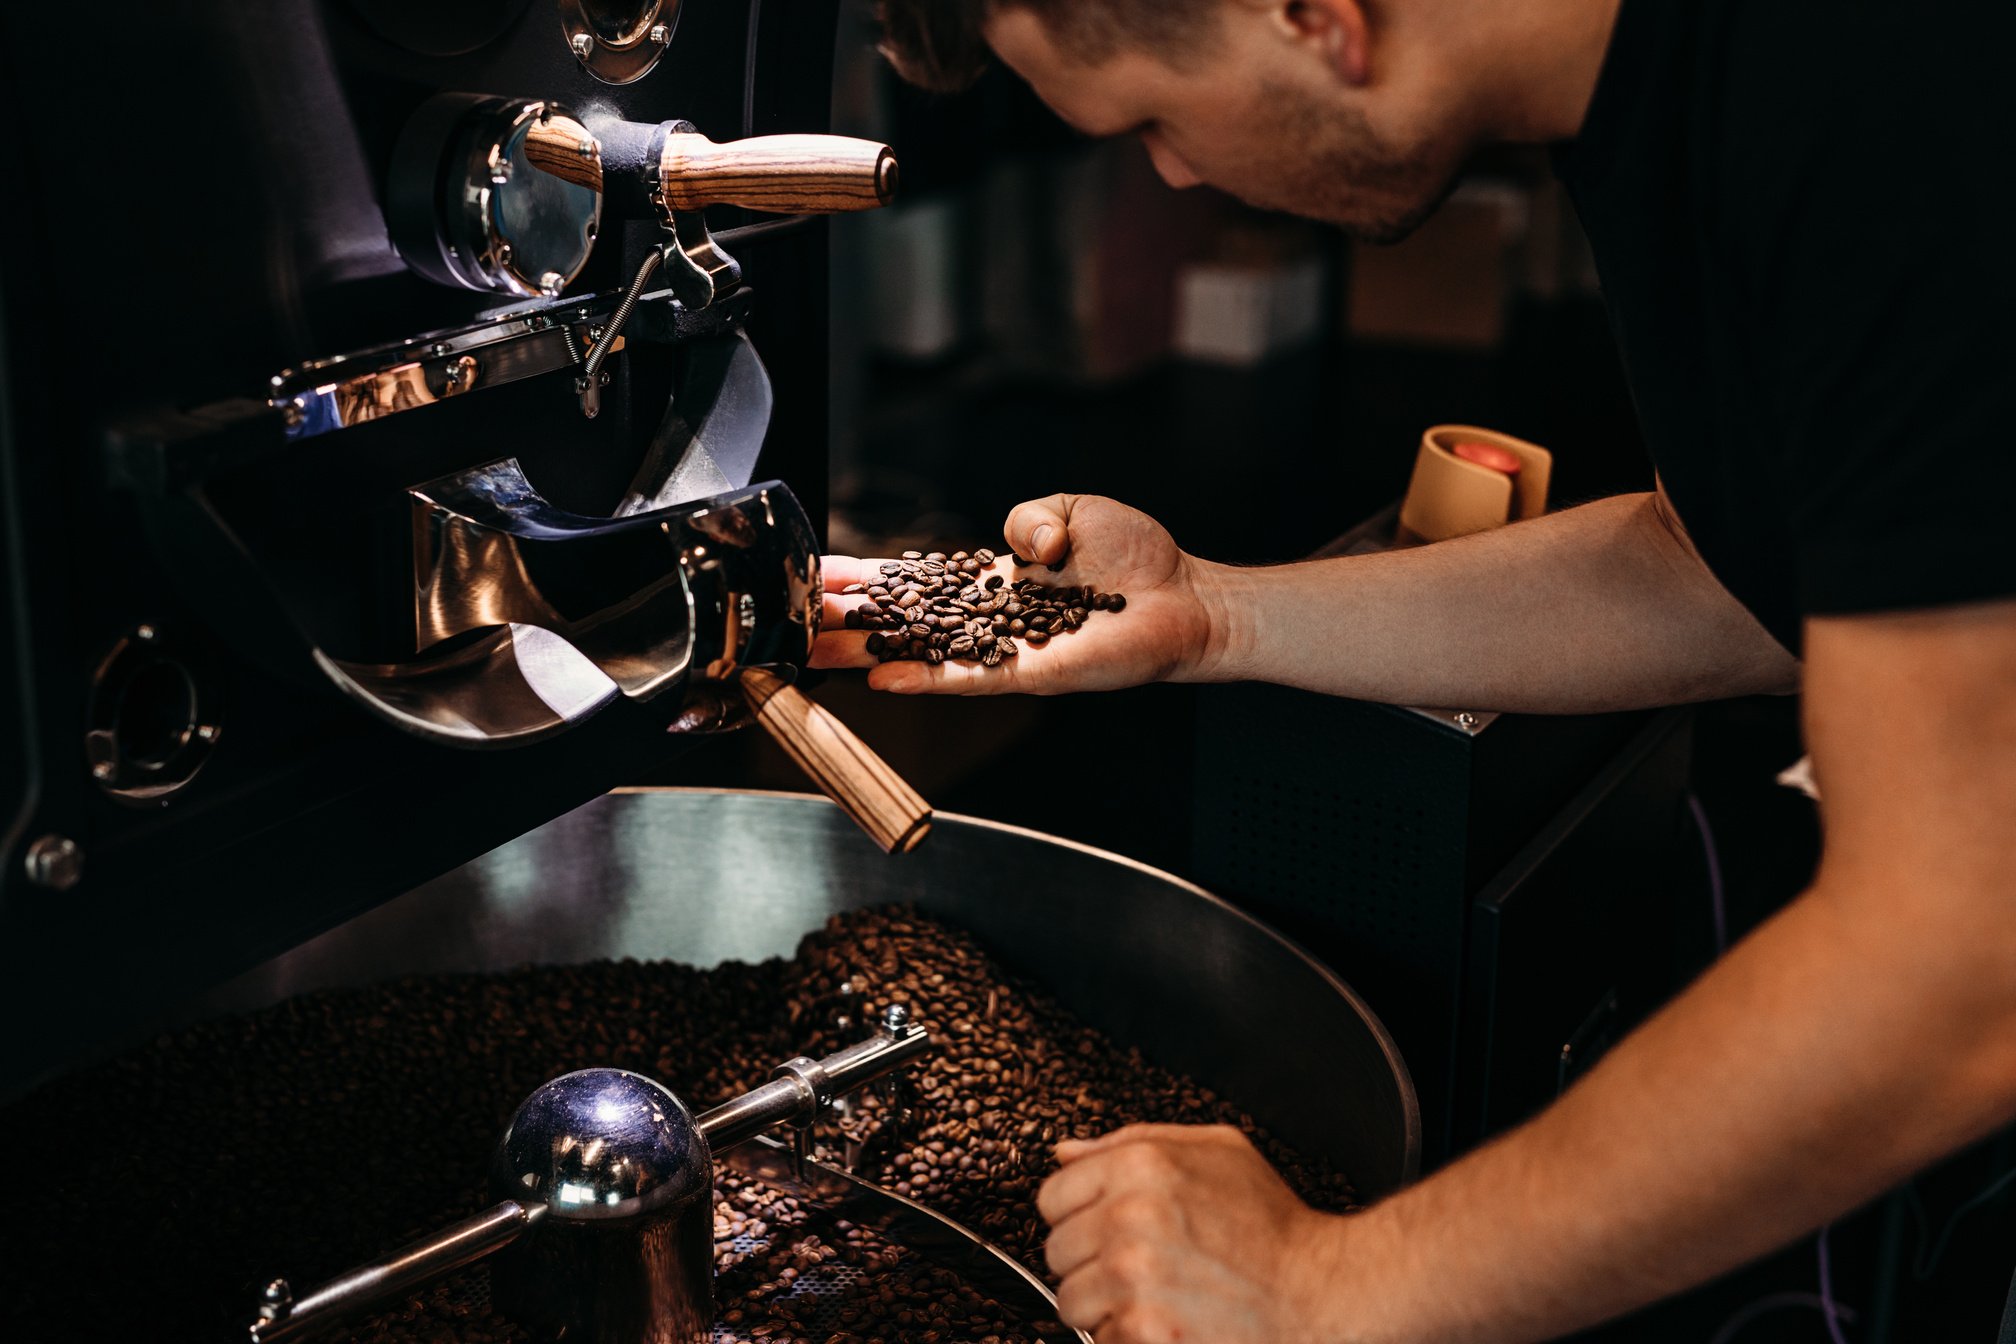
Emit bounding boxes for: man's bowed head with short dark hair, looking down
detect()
[881,0,1572,240]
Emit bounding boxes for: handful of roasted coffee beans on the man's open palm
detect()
[843,550,1127,667]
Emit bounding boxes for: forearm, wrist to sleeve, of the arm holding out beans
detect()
[1208,494,1798,713]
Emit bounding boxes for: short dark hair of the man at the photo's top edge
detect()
[877,0,1224,93]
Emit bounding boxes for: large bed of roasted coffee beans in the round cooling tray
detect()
[0,909,1351,1344]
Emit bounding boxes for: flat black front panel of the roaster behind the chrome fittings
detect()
[0,0,850,1086]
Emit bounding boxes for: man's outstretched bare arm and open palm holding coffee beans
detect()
[814,494,1798,713]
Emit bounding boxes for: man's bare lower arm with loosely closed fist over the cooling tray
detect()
[1042,602,2016,1344]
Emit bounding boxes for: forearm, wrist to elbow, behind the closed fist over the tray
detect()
[1322,891,2016,1344]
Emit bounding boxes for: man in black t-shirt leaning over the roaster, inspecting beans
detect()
[821,0,2016,1344]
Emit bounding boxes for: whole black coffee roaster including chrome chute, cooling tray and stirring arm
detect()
[0,0,1421,1338]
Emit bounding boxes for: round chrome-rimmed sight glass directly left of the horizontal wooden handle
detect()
[385,93,603,298]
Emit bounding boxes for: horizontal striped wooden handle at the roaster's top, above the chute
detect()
[659,133,897,216]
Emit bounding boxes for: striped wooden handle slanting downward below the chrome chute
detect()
[742,667,931,854]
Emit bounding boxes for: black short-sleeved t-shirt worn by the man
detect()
[1556,0,2016,651]
